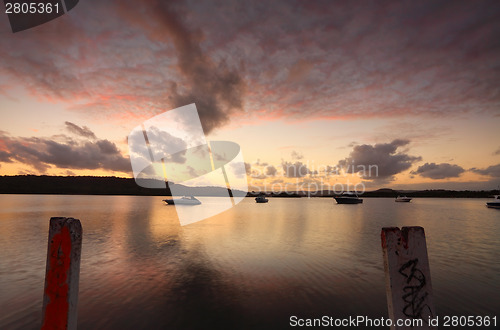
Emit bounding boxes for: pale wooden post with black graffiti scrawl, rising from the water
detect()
[381,227,437,329]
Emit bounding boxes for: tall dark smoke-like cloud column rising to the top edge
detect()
[115,1,245,133]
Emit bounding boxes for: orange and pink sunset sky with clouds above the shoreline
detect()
[0,0,500,191]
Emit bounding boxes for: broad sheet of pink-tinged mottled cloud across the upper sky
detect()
[0,0,500,131]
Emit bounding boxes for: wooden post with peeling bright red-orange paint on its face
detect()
[42,218,82,330]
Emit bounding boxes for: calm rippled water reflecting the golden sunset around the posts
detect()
[0,195,500,329]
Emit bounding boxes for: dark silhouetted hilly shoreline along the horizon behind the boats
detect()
[0,175,500,198]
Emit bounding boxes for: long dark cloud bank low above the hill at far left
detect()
[0,128,131,173]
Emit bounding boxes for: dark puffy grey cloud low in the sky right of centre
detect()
[337,140,422,182]
